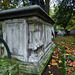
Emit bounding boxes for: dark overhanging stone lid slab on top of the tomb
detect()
[0,5,54,24]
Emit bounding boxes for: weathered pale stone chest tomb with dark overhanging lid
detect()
[0,5,54,75]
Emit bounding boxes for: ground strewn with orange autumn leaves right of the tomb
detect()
[43,36,75,75]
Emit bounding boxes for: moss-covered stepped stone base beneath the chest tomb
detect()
[19,43,55,75]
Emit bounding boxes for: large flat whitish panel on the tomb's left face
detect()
[3,19,28,61]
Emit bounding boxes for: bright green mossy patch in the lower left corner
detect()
[0,57,19,75]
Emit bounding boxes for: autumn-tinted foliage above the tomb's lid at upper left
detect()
[0,0,28,10]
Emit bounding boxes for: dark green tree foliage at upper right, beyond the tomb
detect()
[53,0,75,28]
